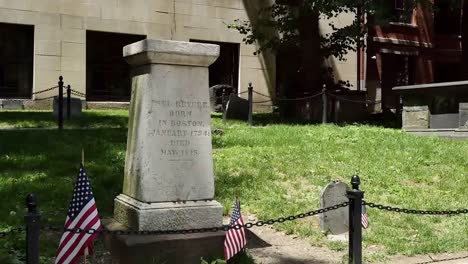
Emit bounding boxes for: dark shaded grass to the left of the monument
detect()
[0,128,127,263]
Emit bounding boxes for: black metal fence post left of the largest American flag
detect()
[25,193,41,264]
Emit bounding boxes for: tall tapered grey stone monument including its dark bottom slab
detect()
[106,40,224,263]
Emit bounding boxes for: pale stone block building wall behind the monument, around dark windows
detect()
[0,0,275,108]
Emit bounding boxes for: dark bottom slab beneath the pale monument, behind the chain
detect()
[103,220,225,264]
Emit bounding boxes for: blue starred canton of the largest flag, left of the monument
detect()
[68,166,93,219]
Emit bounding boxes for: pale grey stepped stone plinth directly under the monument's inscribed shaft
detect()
[114,194,223,231]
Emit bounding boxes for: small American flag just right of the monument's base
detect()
[224,199,247,261]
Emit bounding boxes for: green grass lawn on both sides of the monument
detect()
[0,110,468,263]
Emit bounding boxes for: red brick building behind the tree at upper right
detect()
[368,0,466,112]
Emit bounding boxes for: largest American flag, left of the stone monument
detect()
[55,165,101,264]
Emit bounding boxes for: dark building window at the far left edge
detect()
[0,23,34,98]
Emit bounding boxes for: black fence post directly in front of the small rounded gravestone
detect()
[346,175,364,264]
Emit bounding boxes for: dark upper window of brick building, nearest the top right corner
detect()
[434,0,461,35]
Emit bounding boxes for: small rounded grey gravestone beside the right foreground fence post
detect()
[320,181,349,235]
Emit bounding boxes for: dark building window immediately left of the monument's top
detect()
[86,31,146,102]
